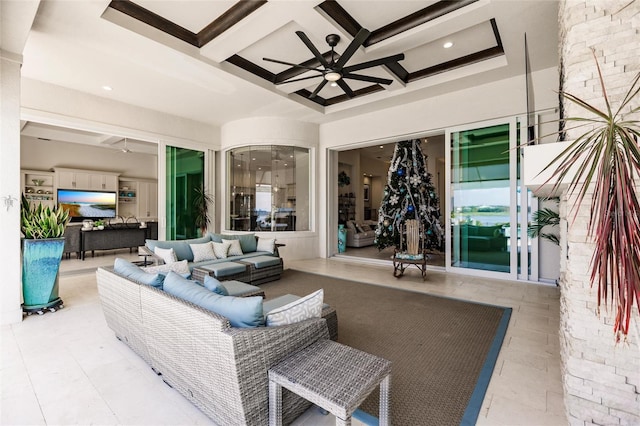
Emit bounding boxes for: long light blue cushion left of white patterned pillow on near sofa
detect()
[164,272,264,327]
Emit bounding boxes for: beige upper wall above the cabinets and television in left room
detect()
[20,136,158,179]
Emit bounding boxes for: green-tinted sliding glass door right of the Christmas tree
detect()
[447,119,530,279]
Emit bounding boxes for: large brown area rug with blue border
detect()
[261,269,511,425]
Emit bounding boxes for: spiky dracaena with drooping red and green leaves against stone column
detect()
[547,54,640,341]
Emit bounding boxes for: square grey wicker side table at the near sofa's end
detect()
[269,340,391,426]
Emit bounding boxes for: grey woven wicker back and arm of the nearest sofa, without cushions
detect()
[96,268,337,425]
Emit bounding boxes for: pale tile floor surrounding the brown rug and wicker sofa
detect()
[0,251,567,426]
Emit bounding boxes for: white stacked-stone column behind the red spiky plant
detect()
[559,0,640,425]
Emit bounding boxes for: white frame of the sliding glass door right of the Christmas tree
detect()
[444,116,538,280]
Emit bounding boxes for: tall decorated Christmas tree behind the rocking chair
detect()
[375,139,442,250]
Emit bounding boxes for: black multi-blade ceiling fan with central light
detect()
[262,28,404,99]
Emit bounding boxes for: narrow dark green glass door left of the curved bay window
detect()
[166,146,205,240]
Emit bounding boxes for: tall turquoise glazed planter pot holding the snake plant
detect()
[22,237,64,312]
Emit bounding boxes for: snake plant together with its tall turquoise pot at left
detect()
[20,194,69,314]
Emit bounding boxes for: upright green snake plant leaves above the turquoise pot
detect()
[20,194,70,240]
